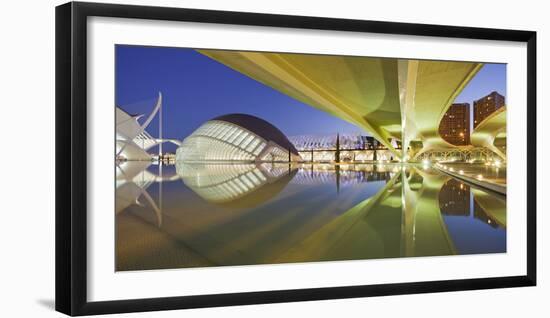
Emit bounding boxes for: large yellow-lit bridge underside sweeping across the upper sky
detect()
[198,50,482,157]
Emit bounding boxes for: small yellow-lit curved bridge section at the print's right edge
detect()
[470,106,506,160]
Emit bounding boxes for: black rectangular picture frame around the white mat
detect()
[55,2,536,315]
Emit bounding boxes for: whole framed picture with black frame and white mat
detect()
[56,2,536,315]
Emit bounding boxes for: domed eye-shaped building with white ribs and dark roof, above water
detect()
[176,114,301,162]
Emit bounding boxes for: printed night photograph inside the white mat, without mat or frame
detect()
[113,44,507,271]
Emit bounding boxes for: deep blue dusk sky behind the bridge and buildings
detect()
[115,45,506,152]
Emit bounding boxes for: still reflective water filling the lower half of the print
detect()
[116,162,506,271]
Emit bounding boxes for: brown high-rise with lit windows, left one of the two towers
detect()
[439,103,470,146]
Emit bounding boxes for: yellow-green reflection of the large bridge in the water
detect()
[274,168,506,262]
